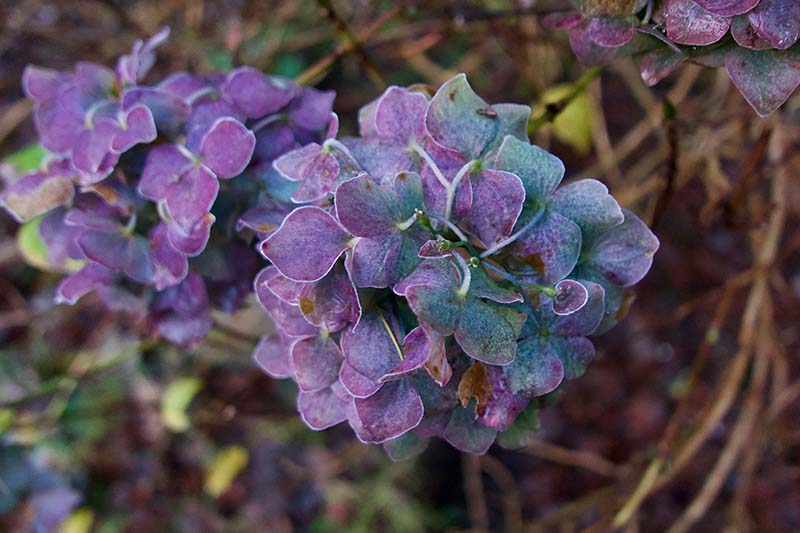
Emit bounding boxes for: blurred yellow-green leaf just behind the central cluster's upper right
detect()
[542,84,597,154]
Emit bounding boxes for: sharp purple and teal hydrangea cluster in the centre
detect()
[254,74,658,458]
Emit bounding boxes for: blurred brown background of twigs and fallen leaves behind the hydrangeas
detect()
[0,0,800,533]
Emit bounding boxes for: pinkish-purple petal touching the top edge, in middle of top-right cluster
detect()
[664,0,731,46]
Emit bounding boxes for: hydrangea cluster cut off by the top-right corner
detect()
[543,0,800,116]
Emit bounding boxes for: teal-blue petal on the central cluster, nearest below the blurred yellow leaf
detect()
[494,136,564,202]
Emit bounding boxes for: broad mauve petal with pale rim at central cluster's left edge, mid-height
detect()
[260,206,351,281]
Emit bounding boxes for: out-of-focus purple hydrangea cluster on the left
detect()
[0,30,337,346]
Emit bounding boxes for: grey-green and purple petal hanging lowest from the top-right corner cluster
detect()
[725,47,800,117]
